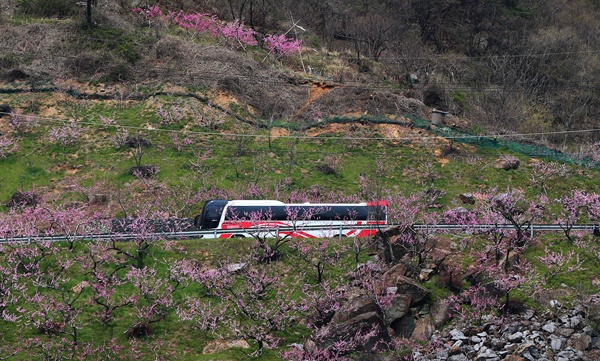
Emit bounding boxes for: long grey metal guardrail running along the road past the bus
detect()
[0,224,600,243]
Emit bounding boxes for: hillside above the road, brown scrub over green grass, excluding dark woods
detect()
[0,2,594,205]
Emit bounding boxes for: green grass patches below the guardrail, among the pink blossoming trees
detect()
[0,226,600,361]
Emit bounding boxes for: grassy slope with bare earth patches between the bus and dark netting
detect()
[0,85,597,208]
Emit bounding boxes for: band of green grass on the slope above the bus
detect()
[0,89,598,205]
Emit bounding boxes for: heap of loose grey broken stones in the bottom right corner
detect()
[413,306,600,361]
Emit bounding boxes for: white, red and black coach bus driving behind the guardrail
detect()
[194,199,388,238]
